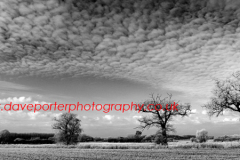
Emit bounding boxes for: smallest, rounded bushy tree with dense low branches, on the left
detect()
[53,113,82,145]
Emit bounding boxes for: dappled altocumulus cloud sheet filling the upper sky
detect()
[0,0,240,98]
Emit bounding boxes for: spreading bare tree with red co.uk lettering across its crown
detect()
[137,94,191,145]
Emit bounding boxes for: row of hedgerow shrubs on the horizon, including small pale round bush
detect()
[0,130,227,144]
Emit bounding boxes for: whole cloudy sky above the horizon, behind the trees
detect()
[0,0,240,137]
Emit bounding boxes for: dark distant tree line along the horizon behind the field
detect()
[0,130,196,144]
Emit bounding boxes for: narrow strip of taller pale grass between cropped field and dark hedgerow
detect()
[0,140,229,149]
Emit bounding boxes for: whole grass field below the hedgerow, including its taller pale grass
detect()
[0,142,240,160]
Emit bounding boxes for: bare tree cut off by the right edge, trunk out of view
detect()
[203,73,240,116]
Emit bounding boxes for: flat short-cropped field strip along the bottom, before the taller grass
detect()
[0,148,240,160]
